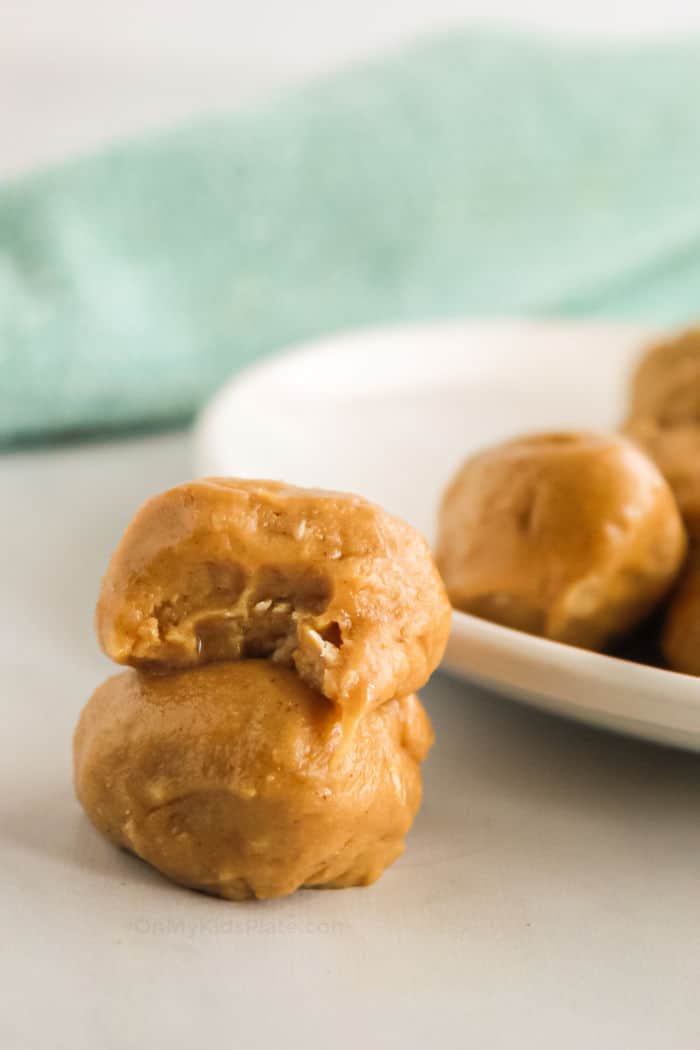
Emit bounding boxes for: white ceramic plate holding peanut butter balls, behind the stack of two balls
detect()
[197,321,700,750]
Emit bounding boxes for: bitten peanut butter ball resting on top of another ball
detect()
[97,478,450,716]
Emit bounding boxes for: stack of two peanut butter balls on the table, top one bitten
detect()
[75,479,450,900]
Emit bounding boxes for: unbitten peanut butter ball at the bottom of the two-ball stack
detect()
[73,660,432,900]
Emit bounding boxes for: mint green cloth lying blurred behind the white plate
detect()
[0,33,700,443]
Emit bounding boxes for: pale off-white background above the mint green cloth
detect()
[0,0,700,175]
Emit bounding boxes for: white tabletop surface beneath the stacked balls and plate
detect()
[0,435,700,1050]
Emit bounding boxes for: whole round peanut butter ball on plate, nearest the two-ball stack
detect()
[438,433,686,649]
